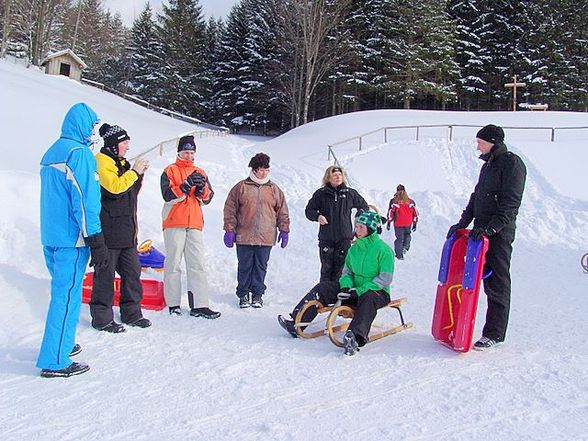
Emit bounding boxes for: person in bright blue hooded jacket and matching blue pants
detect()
[37,103,108,378]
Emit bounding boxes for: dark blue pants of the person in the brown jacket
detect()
[237,244,272,297]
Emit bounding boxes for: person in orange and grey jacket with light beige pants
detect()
[161,135,221,319]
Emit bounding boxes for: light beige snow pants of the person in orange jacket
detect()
[163,228,208,308]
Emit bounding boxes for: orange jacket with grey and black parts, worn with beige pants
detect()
[161,158,214,230]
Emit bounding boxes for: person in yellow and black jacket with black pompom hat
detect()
[90,124,151,333]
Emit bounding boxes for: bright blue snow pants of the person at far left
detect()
[37,246,90,370]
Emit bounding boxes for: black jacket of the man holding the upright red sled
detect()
[459,142,527,233]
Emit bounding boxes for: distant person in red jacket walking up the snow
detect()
[386,184,419,260]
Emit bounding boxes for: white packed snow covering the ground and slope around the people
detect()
[0,62,588,441]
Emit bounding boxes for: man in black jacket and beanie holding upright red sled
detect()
[447,124,527,350]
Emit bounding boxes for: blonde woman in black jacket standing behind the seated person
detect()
[305,165,369,282]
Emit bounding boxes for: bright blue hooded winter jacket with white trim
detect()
[41,103,102,247]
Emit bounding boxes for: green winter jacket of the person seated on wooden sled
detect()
[339,233,394,296]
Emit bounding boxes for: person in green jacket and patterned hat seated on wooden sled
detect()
[278,211,394,355]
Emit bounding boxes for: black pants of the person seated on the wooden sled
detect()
[290,282,390,346]
